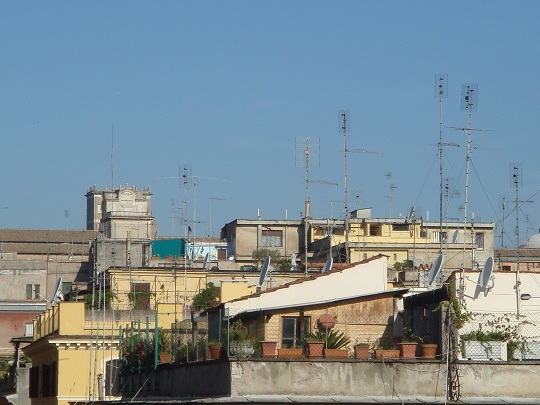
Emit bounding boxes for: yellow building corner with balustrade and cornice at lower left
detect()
[23,302,122,405]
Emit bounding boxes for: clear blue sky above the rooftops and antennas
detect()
[0,1,540,245]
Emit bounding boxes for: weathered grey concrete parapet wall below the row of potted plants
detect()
[124,359,540,403]
